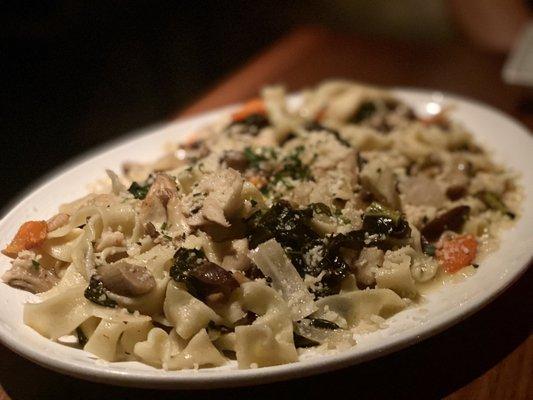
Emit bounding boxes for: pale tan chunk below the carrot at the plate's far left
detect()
[2,250,59,293]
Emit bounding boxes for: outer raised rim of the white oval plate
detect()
[0,86,533,389]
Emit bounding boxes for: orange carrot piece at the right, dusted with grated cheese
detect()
[436,235,477,274]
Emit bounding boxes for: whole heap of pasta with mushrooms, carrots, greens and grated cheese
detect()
[3,81,520,370]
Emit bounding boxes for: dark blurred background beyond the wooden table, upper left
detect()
[0,0,460,210]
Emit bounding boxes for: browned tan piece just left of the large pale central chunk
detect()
[140,174,178,226]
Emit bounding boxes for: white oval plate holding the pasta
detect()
[0,89,533,388]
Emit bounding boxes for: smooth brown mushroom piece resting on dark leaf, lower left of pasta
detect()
[98,261,155,297]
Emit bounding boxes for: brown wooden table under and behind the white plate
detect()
[0,28,533,400]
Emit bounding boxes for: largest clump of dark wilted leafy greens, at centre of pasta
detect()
[246,200,411,296]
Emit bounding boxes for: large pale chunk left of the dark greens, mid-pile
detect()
[188,168,243,227]
